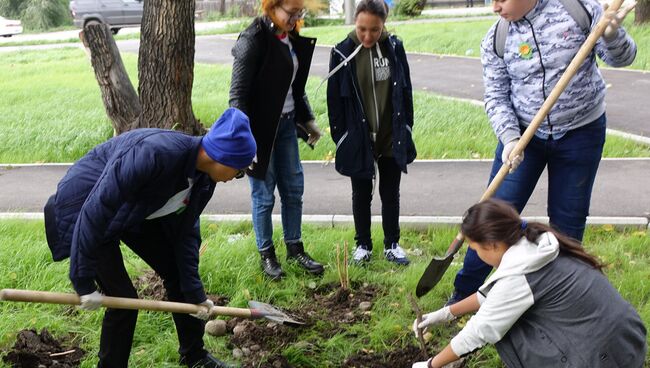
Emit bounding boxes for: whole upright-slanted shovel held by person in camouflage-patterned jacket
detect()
[415,0,623,298]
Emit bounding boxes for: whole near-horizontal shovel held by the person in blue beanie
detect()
[0,289,304,326]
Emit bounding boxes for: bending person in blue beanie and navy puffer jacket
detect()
[44,108,257,367]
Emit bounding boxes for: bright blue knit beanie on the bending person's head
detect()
[201,107,257,169]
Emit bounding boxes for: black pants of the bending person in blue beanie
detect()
[96,220,207,368]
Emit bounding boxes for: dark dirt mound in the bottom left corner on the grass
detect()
[2,329,86,368]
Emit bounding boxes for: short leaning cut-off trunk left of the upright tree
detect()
[79,23,142,134]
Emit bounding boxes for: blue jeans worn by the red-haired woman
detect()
[248,113,305,252]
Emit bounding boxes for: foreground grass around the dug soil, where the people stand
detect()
[0,221,650,368]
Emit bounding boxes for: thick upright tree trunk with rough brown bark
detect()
[138,0,200,135]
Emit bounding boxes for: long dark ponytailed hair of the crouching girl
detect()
[461,199,604,271]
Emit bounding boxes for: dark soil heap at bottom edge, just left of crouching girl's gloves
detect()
[341,345,430,368]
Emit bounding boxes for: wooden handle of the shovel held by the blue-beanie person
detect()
[0,289,253,318]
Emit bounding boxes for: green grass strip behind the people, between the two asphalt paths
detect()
[0,48,650,163]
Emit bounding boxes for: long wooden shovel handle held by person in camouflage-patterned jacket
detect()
[440,0,624,254]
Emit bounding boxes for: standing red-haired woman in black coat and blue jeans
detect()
[230,0,323,279]
